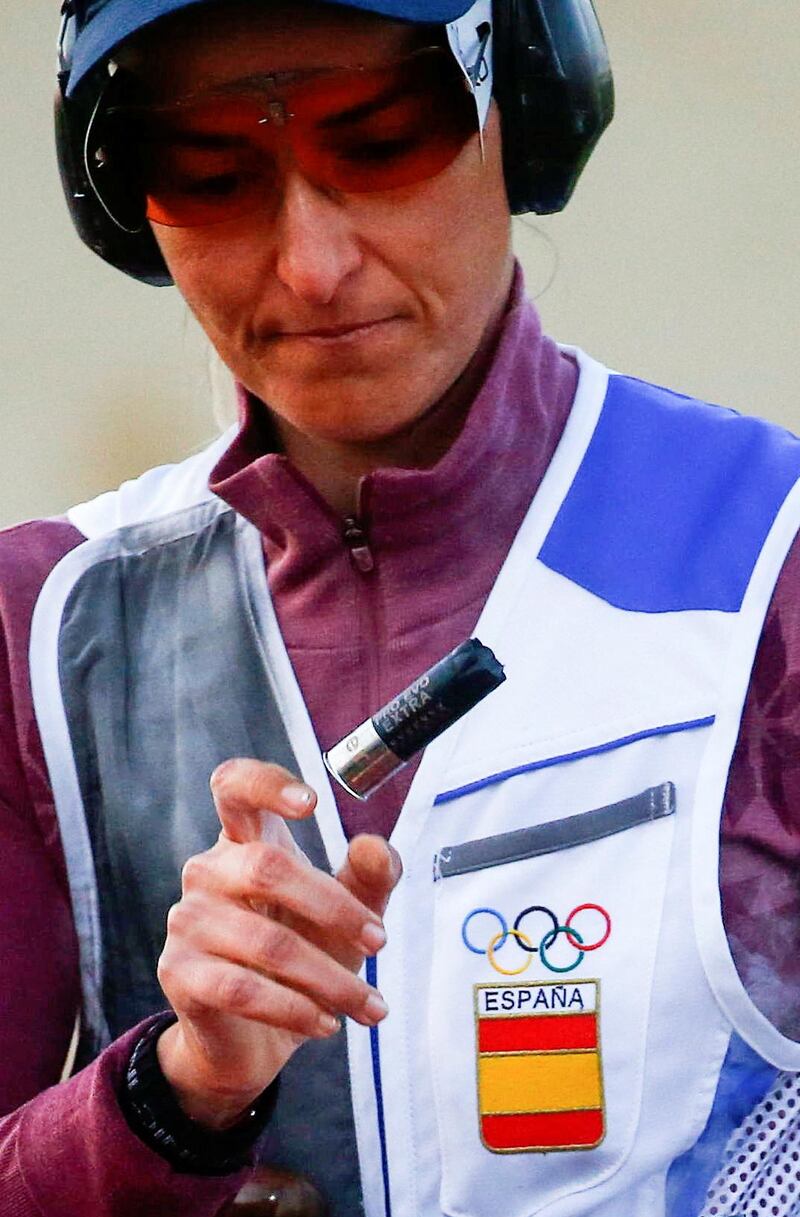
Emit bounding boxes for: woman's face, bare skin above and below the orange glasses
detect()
[142,5,511,443]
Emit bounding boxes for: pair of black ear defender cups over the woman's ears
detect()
[55,0,614,287]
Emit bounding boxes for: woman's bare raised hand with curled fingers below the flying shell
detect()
[153,759,401,1128]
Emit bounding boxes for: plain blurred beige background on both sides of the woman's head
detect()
[0,0,800,523]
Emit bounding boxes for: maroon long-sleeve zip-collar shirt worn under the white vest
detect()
[0,277,800,1217]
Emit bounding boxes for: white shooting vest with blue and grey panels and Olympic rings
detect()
[32,353,800,1217]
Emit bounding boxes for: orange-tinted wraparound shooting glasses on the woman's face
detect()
[96,46,477,228]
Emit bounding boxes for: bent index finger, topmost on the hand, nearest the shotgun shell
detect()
[211,757,317,842]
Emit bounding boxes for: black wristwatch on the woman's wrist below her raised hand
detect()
[119,1013,278,1176]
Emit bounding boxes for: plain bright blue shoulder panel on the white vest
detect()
[539,376,800,612]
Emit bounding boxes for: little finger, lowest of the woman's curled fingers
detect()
[158,949,341,1039]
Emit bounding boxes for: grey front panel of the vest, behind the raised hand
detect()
[60,504,363,1217]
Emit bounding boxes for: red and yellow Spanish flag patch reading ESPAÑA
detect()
[475,980,605,1154]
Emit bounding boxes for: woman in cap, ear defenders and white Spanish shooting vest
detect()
[0,0,800,1217]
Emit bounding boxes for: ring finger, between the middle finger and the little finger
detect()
[167,898,387,1026]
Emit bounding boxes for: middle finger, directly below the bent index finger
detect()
[183,841,386,954]
